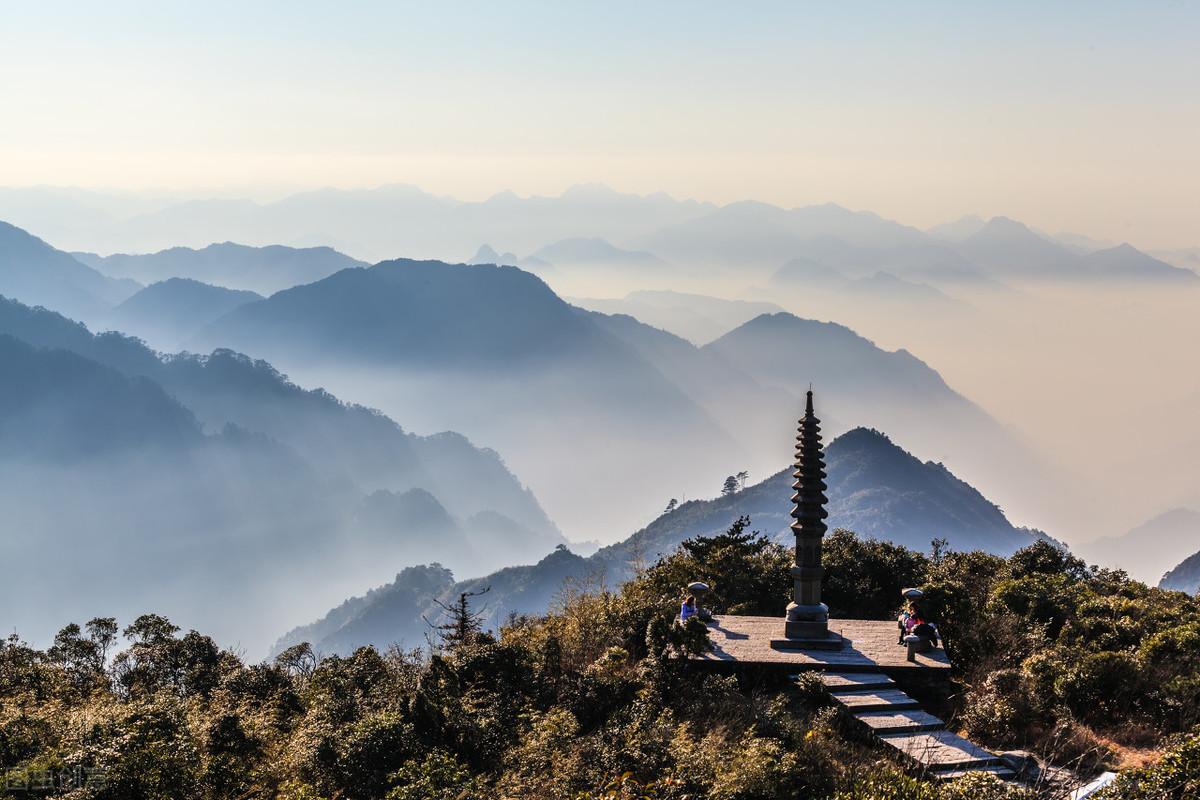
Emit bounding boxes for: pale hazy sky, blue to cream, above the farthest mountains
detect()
[0,0,1200,247]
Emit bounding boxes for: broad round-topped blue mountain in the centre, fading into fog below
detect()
[182,260,1019,541]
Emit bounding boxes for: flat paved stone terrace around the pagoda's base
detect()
[697,614,950,675]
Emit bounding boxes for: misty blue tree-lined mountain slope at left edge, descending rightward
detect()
[0,293,564,646]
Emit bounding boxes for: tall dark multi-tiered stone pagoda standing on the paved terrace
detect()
[772,390,844,650]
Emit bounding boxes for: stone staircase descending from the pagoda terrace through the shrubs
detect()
[821,672,1015,780]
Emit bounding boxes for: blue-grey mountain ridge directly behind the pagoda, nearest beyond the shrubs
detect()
[272,428,1044,652]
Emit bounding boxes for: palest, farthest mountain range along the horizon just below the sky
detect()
[0,191,1195,294]
